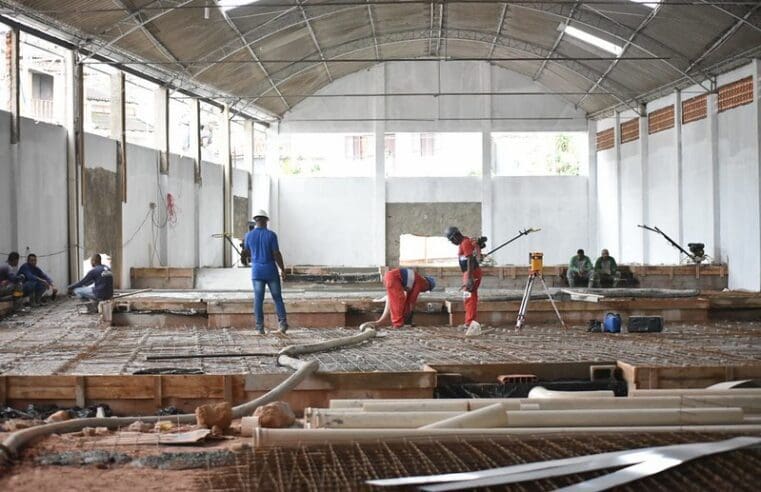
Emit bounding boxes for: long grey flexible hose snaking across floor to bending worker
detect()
[0,329,376,464]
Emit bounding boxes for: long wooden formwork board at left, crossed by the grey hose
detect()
[0,371,436,418]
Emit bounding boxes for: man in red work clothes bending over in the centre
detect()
[373,268,436,328]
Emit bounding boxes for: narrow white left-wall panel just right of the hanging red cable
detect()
[198,162,225,267]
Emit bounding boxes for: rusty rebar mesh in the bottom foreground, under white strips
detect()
[197,433,761,492]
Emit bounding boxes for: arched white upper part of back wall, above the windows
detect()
[280,61,587,133]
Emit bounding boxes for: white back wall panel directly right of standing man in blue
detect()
[278,177,374,266]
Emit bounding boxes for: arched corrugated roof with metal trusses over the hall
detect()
[3,0,761,119]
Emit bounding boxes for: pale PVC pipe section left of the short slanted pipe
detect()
[304,409,461,429]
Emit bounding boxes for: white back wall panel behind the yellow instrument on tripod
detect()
[489,176,593,265]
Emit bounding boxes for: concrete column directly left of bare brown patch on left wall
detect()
[66,52,85,282]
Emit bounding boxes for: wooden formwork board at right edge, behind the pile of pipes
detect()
[617,361,761,389]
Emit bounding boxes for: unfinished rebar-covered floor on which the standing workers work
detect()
[0,300,761,375]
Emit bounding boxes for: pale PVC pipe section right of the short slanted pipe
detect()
[507,408,743,427]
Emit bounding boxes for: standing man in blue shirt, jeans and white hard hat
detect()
[244,210,288,334]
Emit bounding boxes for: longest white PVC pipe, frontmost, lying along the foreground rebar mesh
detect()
[253,425,761,447]
